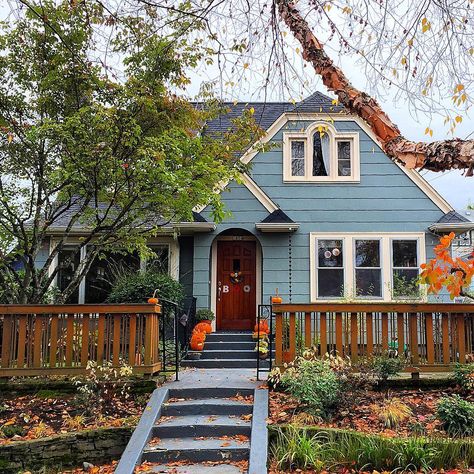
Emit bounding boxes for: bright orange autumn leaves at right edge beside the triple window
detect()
[420,232,474,299]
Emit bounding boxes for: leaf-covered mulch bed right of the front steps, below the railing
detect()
[269,388,474,437]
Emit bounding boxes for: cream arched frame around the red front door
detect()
[210,235,262,331]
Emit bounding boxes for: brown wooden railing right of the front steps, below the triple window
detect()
[272,303,474,371]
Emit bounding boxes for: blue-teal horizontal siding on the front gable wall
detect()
[194,121,443,307]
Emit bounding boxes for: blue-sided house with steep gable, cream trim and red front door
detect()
[38,92,474,329]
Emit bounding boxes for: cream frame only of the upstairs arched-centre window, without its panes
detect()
[283,121,360,183]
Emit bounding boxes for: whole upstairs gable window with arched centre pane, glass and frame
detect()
[283,121,360,183]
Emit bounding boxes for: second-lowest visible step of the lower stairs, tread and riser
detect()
[152,415,252,438]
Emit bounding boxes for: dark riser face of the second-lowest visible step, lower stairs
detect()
[153,424,251,438]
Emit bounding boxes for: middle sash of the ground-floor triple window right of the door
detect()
[354,239,382,298]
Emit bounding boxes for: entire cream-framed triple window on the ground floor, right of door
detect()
[310,232,425,301]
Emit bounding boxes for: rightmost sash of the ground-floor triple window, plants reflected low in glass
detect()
[392,239,419,298]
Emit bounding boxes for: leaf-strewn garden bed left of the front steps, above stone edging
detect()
[0,388,147,444]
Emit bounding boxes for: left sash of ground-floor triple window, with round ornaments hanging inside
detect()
[317,240,344,298]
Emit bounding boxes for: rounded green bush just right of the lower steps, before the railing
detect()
[280,358,344,418]
